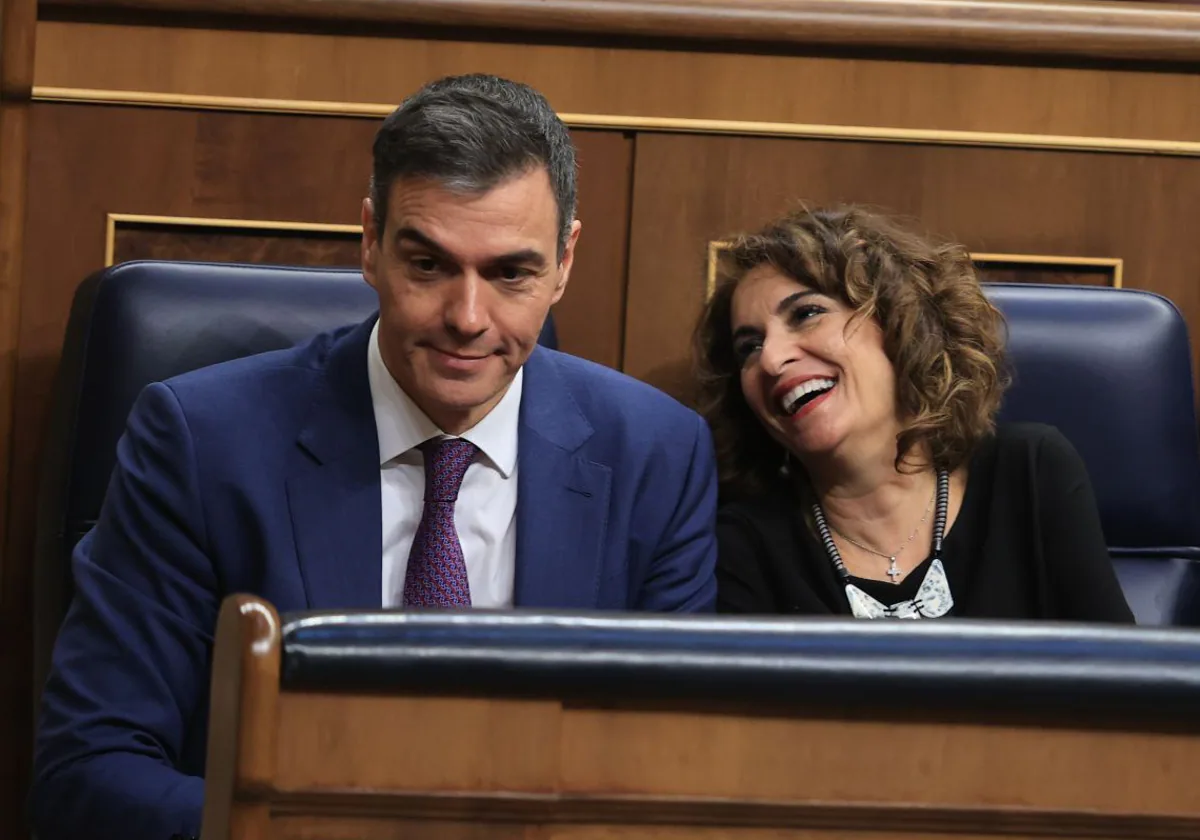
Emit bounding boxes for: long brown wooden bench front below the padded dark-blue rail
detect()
[267,692,1200,816]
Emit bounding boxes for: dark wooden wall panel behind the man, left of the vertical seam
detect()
[7,103,632,836]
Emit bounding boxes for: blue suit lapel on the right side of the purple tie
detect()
[514,348,612,610]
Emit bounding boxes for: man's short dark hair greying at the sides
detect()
[371,73,578,259]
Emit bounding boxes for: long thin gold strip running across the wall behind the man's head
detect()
[34,86,1200,157]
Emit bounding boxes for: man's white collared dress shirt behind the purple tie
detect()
[367,322,524,607]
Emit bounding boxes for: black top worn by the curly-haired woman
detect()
[716,424,1134,623]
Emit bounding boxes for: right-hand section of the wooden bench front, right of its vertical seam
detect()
[559,703,1200,816]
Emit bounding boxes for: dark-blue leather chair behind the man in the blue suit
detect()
[34,260,558,692]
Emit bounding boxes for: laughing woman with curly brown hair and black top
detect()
[696,208,1133,622]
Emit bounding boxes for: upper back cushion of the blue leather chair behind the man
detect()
[61,262,378,518]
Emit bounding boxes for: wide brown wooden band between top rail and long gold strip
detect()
[36,20,1200,142]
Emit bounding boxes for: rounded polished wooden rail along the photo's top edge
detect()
[35,0,1200,62]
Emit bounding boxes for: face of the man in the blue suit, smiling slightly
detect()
[362,167,580,434]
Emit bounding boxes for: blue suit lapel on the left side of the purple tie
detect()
[287,318,383,610]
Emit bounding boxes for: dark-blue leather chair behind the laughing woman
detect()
[985,283,1200,626]
